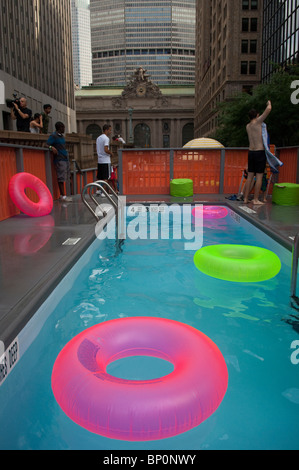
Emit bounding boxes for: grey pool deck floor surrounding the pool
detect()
[0,194,299,348]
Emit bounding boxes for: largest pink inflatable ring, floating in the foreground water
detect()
[52,317,228,441]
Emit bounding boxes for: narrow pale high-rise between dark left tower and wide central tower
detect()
[71,0,92,88]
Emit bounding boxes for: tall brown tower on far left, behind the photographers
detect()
[0,0,76,132]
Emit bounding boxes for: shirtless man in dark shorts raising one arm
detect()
[244,101,272,205]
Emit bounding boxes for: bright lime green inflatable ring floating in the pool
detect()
[194,245,281,282]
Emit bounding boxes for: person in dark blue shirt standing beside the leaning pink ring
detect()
[47,121,72,202]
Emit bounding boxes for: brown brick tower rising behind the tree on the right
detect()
[194,0,263,137]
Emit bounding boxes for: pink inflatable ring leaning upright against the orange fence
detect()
[8,172,53,217]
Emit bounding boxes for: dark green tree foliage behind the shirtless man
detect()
[212,66,299,147]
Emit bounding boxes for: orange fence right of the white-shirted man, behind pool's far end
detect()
[119,146,298,195]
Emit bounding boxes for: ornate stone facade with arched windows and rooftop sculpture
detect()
[76,67,194,148]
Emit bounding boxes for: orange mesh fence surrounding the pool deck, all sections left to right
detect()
[0,144,299,220]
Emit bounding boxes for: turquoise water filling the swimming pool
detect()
[0,206,299,450]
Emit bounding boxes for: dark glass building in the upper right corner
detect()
[262,0,299,81]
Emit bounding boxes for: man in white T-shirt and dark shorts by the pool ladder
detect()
[96,124,113,197]
